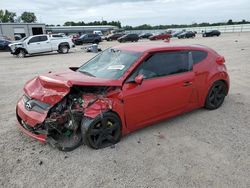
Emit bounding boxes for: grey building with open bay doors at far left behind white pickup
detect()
[0,23,45,40]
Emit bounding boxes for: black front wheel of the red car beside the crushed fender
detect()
[81,112,121,149]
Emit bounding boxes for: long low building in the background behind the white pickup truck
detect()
[45,25,118,35]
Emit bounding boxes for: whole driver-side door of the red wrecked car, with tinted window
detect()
[122,51,194,131]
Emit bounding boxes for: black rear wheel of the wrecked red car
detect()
[205,81,227,110]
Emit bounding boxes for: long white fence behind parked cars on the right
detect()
[126,24,250,34]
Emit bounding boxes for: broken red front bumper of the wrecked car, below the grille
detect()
[16,98,47,143]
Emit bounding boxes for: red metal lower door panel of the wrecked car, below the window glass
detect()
[123,72,194,130]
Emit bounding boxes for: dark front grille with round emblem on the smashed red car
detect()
[23,95,50,113]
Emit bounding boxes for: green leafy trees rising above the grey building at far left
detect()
[0,10,37,23]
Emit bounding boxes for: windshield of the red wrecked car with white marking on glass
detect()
[78,49,141,80]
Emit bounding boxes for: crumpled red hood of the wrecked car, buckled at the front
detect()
[24,70,122,105]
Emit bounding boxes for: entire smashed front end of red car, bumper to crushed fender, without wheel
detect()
[17,85,119,151]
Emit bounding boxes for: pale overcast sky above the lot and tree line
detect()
[0,0,250,26]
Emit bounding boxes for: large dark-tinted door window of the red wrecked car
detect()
[138,51,190,79]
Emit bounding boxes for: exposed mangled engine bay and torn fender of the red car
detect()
[22,86,115,151]
